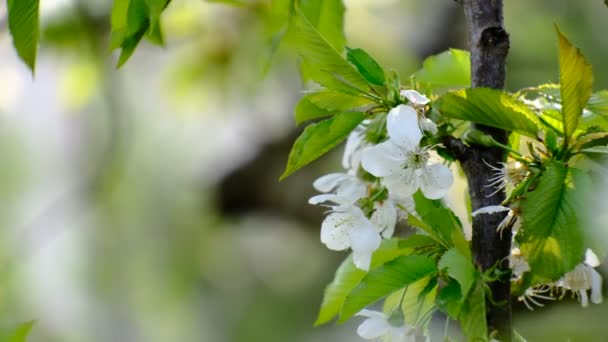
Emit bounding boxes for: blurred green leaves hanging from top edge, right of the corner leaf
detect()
[110,0,170,67]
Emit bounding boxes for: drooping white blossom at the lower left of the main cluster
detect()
[309,194,382,271]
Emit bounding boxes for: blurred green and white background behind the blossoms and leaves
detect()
[0,0,608,342]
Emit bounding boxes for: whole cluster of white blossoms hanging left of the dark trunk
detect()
[309,90,453,271]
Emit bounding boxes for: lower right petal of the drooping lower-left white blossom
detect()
[348,223,382,271]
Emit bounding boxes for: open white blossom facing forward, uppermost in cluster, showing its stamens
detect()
[361,105,454,199]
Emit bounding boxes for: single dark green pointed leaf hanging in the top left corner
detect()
[7,0,40,73]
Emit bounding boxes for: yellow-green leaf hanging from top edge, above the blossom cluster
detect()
[298,0,346,51]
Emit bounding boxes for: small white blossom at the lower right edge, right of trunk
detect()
[556,249,602,307]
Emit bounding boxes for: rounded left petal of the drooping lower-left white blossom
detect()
[321,212,357,251]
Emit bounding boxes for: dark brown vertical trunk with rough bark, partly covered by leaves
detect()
[460,0,512,341]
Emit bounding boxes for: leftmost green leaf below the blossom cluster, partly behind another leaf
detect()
[315,240,404,326]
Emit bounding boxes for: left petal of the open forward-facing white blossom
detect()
[361,140,405,177]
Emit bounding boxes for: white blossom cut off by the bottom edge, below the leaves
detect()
[357,309,416,342]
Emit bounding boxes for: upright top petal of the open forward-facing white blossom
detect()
[386,104,422,150]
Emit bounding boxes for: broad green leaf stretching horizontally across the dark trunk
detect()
[434,88,540,138]
